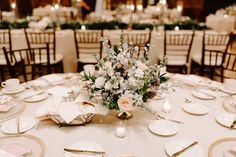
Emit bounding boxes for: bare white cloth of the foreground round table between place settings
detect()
[0,74,236,157]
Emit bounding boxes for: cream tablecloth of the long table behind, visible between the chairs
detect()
[12,30,202,72]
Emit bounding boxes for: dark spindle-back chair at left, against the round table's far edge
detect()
[3,44,51,81]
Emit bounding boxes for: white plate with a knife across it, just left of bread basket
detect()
[1,117,36,134]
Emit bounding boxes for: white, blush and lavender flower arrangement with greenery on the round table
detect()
[84,35,166,117]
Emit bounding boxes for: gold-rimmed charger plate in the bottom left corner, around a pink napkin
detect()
[0,134,45,157]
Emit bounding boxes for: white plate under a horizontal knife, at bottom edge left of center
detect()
[64,141,104,157]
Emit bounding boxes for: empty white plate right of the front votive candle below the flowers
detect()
[148,120,179,136]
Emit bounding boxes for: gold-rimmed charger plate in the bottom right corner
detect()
[208,137,236,157]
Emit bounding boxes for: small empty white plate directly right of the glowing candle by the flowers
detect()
[183,103,209,115]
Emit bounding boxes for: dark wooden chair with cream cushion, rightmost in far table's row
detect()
[192,31,232,82]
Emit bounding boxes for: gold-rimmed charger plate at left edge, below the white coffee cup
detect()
[0,98,25,122]
